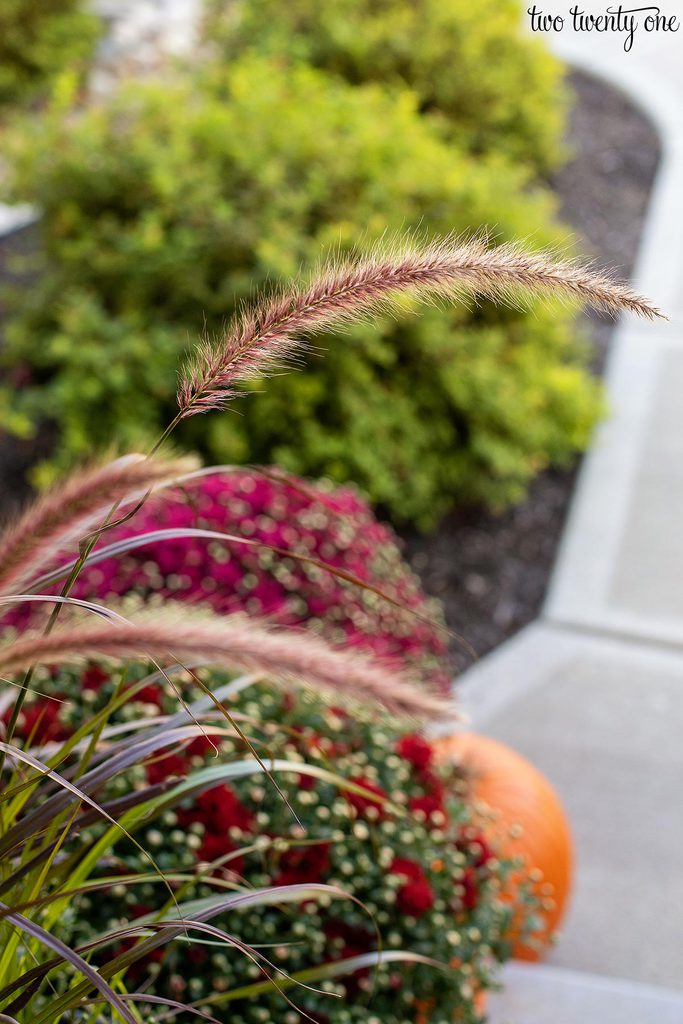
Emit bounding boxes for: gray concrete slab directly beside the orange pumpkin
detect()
[456,623,683,991]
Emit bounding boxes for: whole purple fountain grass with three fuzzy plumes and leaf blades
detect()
[0,238,660,1021]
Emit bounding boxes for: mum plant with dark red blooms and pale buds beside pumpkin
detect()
[10,664,542,1024]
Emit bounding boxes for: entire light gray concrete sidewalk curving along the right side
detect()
[460,6,683,1024]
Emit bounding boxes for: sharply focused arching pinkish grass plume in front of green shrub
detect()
[175,237,661,422]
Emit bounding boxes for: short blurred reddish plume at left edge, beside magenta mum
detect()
[0,455,197,594]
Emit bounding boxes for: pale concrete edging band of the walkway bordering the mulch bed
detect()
[544,48,683,645]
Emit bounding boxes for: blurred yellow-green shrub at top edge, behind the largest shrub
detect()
[206,0,565,171]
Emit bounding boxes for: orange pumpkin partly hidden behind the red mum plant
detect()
[434,732,573,961]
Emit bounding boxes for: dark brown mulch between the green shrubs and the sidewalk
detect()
[405,75,659,670]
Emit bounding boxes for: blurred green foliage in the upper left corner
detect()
[0,0,99,105]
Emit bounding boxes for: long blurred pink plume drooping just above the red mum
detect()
[0,608,454,719]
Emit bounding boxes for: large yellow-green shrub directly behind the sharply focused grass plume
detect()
[0,55,599,527]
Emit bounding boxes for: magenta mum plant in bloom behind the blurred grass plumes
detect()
[65,470,450,688]
